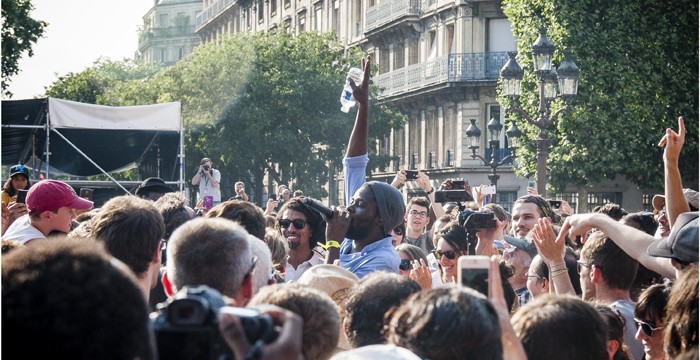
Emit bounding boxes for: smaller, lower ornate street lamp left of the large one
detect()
[466,118,521,203]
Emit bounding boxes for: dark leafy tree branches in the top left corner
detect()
[2,0,48,97]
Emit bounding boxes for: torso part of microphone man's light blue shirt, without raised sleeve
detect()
[340,236,401,278]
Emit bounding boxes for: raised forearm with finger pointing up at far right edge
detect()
[659,116,690,227]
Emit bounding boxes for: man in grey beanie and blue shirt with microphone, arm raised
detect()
[326,56,406,278]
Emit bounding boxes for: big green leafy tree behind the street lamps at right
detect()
[503,0,698,191]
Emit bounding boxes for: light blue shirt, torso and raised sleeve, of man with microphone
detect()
[340,154,401,278]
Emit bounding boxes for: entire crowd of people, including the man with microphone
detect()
[2,58,698,360]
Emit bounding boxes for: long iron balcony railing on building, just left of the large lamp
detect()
[376,52,508,97]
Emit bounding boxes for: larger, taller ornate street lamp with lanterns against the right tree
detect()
[501,28,579,195]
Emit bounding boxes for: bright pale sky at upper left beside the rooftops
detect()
[4,0,154,100]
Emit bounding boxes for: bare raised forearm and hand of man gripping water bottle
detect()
[345,55,372,157]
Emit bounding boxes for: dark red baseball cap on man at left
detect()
[26,180,93,214]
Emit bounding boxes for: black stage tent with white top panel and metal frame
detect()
[2,98,185,192]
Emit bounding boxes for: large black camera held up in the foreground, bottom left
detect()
[150,285,279,360]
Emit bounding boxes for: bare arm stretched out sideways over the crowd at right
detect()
[557,213,676,279]
